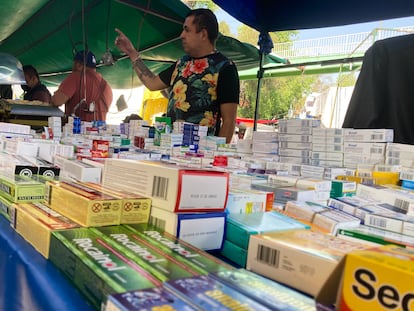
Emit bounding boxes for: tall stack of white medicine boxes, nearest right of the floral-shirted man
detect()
[279,119,321,164]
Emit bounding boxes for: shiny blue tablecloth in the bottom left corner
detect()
[0,215,94,311]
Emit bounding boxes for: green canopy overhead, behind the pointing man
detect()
[0,0,284,89]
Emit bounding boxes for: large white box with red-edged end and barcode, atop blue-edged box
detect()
[102,159,229,212]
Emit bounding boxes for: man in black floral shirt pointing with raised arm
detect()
[115,9,240,143]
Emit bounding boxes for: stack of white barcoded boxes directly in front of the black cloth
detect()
[343,129,394,168]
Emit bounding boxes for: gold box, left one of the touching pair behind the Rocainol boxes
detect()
[46,181,122,227]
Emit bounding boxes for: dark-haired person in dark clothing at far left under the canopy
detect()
[22,65,52,103]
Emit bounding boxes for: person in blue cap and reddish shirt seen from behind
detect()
[51,51,113,121]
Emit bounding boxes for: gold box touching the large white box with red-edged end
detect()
[81,183,151,224]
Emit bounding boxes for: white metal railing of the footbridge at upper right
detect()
[273,26,414,59]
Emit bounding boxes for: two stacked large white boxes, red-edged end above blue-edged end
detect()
[102,159,229,250]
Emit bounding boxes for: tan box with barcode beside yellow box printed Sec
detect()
[246,230,365,296]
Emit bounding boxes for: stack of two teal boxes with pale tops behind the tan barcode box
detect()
[220,211,309,268]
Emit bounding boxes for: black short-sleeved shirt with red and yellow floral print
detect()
[160,52,240,135]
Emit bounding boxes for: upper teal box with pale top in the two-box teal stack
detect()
[225,212,310,250]
